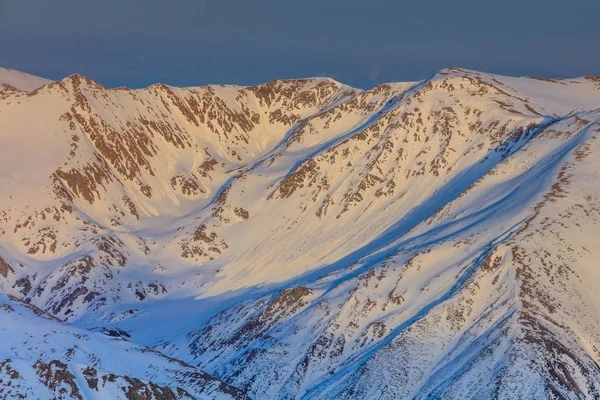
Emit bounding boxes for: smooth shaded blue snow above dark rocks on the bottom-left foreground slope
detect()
[0,295,246,399]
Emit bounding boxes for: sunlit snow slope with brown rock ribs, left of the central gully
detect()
[0,75,354,318]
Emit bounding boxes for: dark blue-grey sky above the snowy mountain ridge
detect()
[0,0,600,87]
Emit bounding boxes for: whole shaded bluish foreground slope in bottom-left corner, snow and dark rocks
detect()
[0,295,246,399]
